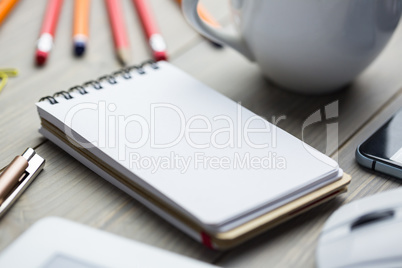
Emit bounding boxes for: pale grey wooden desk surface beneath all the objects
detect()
[0,0,402,268]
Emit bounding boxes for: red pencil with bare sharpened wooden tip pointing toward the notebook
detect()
[106,0,130,65]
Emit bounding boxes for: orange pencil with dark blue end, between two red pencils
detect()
[73,0,91,56]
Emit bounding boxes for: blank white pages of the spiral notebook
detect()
[37,62,339,227]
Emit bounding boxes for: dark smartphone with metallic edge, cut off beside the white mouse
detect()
[356,110,402,179]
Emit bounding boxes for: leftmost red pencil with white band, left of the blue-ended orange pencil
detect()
[35,0,63,65]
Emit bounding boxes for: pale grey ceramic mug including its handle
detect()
[182,0,402,93]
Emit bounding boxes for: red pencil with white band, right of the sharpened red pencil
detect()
[133,0,167,61]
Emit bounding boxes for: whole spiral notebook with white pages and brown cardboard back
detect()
[36,62,350,248]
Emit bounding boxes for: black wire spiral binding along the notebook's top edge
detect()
[39,60,159,105]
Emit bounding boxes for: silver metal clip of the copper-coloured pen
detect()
[0,148,45,217]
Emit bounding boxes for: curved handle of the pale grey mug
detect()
[182,0,255,61]
